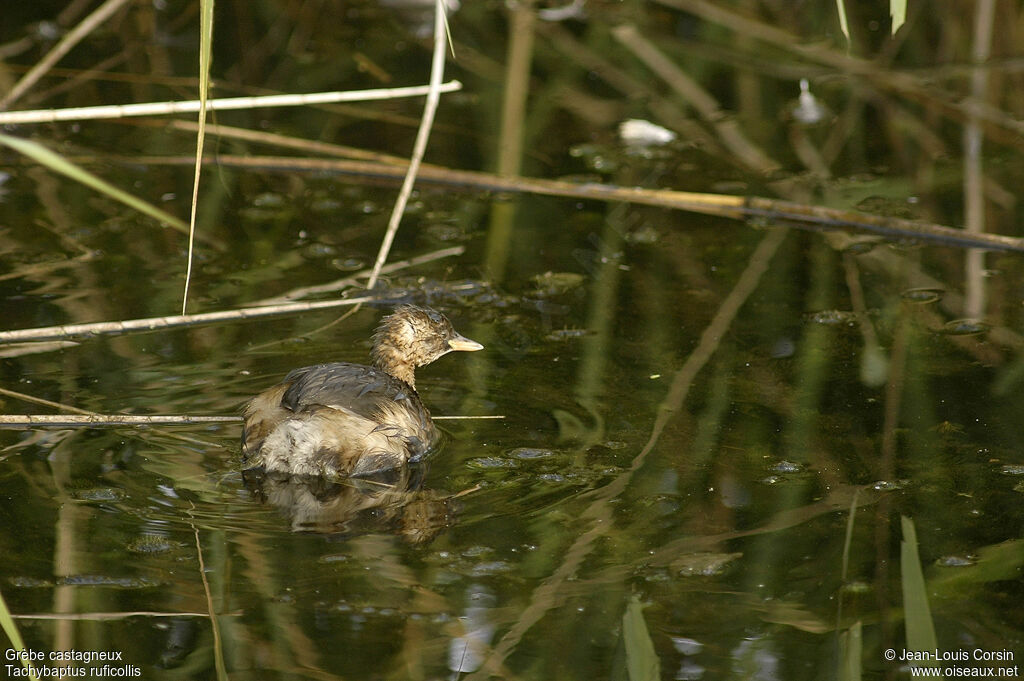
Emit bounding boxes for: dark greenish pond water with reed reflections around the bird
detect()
[0,2,1024,681]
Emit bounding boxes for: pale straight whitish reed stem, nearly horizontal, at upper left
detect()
[0,81,462,125]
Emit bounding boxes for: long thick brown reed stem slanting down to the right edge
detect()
[117,155,1024,253]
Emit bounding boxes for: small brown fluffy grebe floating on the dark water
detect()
[242,305,483,476]
